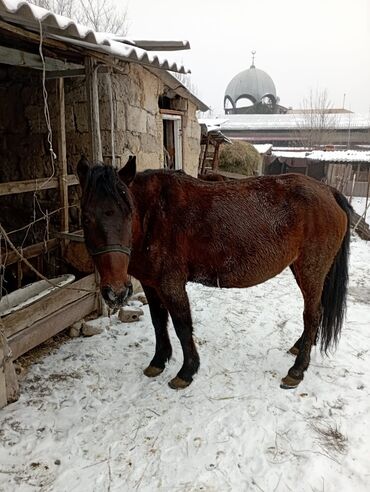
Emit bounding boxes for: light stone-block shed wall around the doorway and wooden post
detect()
[66,63,200,176]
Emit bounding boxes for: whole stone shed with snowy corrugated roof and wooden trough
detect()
[0,0,208,407]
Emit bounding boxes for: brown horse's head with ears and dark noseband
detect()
[77,156,136,309]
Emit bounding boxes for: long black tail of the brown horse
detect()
[318,188,353,353]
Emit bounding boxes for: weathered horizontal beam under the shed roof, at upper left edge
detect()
[0,46,82,71]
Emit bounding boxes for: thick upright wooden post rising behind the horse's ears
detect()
[85,57,103,163]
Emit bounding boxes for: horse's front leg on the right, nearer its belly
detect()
[161,281,199,389]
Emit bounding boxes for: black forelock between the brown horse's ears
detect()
[83,164,133,210]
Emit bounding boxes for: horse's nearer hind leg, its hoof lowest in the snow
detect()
[281,265,325,389]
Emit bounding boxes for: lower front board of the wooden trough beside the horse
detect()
[8,294,96,359]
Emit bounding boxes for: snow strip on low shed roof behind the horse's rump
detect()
[272,150,370,162]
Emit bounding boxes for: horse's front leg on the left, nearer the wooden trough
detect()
[143,285,172,378]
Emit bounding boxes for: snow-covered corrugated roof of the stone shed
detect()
[0,0,190,73]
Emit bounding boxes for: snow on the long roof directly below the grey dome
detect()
[221,113,370,131]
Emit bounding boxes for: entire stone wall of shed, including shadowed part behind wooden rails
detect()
[0,63,200,243]
